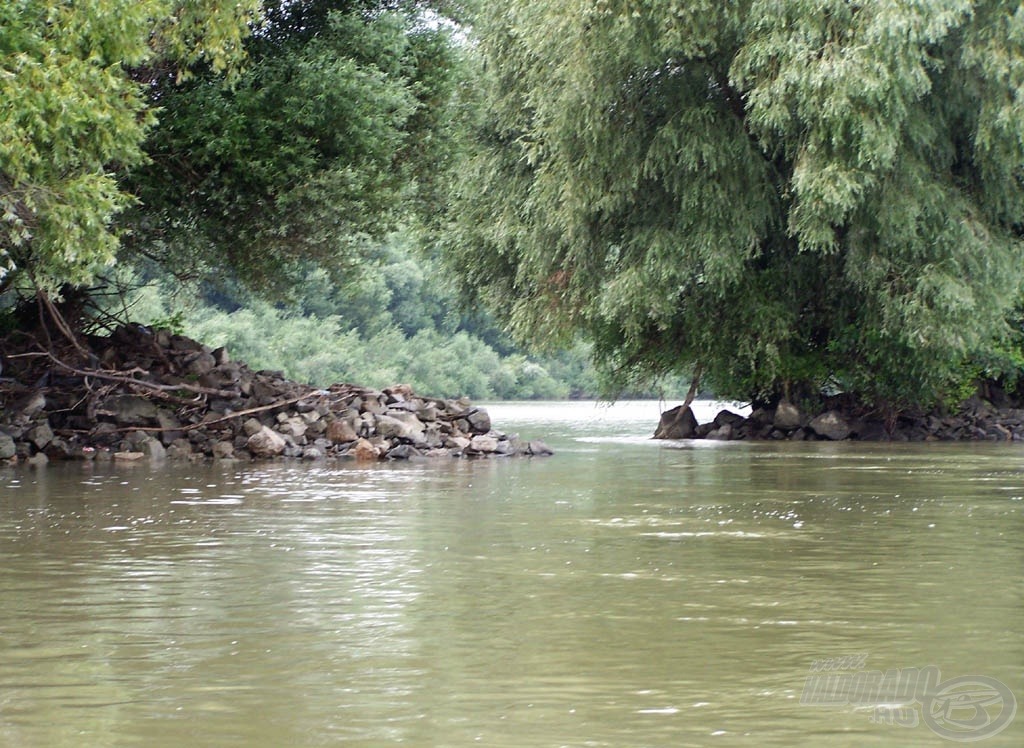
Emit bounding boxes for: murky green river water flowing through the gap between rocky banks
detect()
[0,403,1024,748]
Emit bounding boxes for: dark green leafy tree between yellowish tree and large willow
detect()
[124,0,468,292]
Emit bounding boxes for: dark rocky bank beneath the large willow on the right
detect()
[654,396,1024,442]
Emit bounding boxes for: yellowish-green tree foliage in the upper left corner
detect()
[0,0,259,291]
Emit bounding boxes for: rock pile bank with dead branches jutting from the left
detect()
[0,326,551,465]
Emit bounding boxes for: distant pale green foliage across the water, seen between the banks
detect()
[121,227,630,400]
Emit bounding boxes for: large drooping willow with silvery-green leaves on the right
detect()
[451,0,1024,405]
